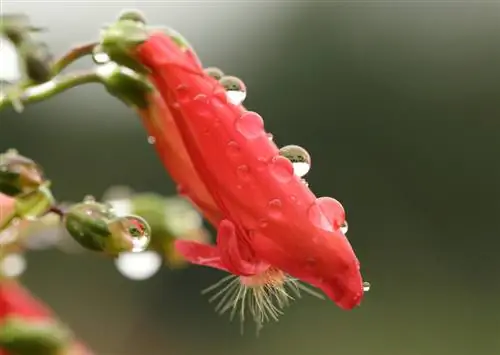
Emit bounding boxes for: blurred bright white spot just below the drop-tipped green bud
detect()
[115,251,162,280]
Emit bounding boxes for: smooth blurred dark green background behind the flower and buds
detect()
[0,0,500,355]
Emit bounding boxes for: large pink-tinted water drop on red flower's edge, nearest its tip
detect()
[308,197,345,232]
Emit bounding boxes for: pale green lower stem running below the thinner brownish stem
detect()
[0,70,102,110]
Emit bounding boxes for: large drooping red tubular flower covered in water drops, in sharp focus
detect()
[138,34,363,321]
